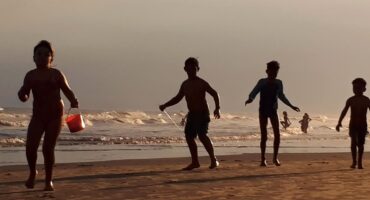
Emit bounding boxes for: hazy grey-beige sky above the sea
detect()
[0,0,370,114]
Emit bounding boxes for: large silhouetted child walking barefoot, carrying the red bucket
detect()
[18,40,78,191]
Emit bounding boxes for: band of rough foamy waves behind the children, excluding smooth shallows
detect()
[0,109,364,145]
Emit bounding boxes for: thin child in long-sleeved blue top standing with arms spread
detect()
[245,61,299,166]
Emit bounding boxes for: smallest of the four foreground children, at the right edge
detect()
[336,78,370,169]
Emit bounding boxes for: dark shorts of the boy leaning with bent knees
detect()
[185,112,211,138]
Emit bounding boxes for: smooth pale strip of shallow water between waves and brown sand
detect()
[0,139,358,166]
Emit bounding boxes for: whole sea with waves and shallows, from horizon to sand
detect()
[0,108,369,165]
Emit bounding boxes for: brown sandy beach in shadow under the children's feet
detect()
[0,153,370,200]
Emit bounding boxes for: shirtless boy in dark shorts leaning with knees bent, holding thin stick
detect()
[159,57,220,170]
